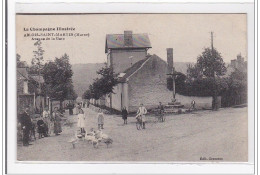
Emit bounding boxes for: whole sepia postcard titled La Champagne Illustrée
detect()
[13,13,248,163]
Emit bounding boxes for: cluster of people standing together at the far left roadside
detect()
[19,107,63,146]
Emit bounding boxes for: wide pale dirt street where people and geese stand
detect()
[17,108,248,161]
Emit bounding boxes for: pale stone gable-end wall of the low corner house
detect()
[128,55,172,112]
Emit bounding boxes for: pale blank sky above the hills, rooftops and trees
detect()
[16,14,247,64]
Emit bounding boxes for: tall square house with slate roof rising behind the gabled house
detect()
[105,31,151,74]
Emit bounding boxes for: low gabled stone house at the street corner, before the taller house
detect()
[111,55,175,112]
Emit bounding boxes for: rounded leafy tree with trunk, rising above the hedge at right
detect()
[187,47,227,110]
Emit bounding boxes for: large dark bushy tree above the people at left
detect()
[43,53,77,109]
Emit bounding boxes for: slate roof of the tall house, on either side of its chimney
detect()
[105,33,152,53]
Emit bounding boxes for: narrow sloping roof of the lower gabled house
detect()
[118,55,154,83]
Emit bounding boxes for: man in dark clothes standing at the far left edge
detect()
[20,107,32,146]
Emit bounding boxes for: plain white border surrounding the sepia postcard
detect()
[7,0,255,174]
